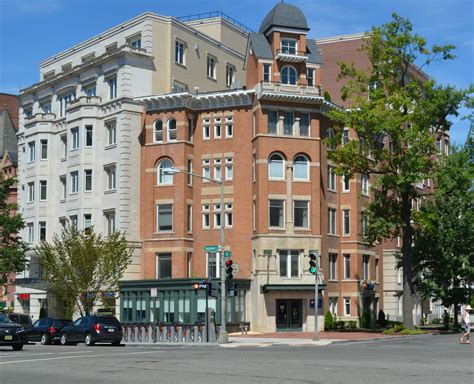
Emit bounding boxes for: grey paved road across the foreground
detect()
[0,335,474,384]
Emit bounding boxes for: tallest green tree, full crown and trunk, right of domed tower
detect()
[327,14,466,328]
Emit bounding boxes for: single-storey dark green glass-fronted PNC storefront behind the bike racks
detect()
[120,279,250,324]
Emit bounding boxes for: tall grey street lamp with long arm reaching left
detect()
[161,168,229,344]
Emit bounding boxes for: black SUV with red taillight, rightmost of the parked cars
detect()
[61,315,123,346]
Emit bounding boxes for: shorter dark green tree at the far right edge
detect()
[413,148,474,327]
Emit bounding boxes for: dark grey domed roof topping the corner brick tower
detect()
[259,3,309,33]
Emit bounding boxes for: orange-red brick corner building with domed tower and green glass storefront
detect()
[121,3,383,331]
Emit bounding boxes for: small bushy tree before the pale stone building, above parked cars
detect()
[36,225,133,315]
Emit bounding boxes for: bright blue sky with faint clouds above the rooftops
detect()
[0,0,474,144]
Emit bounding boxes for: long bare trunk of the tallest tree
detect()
[402,193,415,329]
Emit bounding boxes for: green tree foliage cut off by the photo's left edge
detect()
[0,172,27,294]
